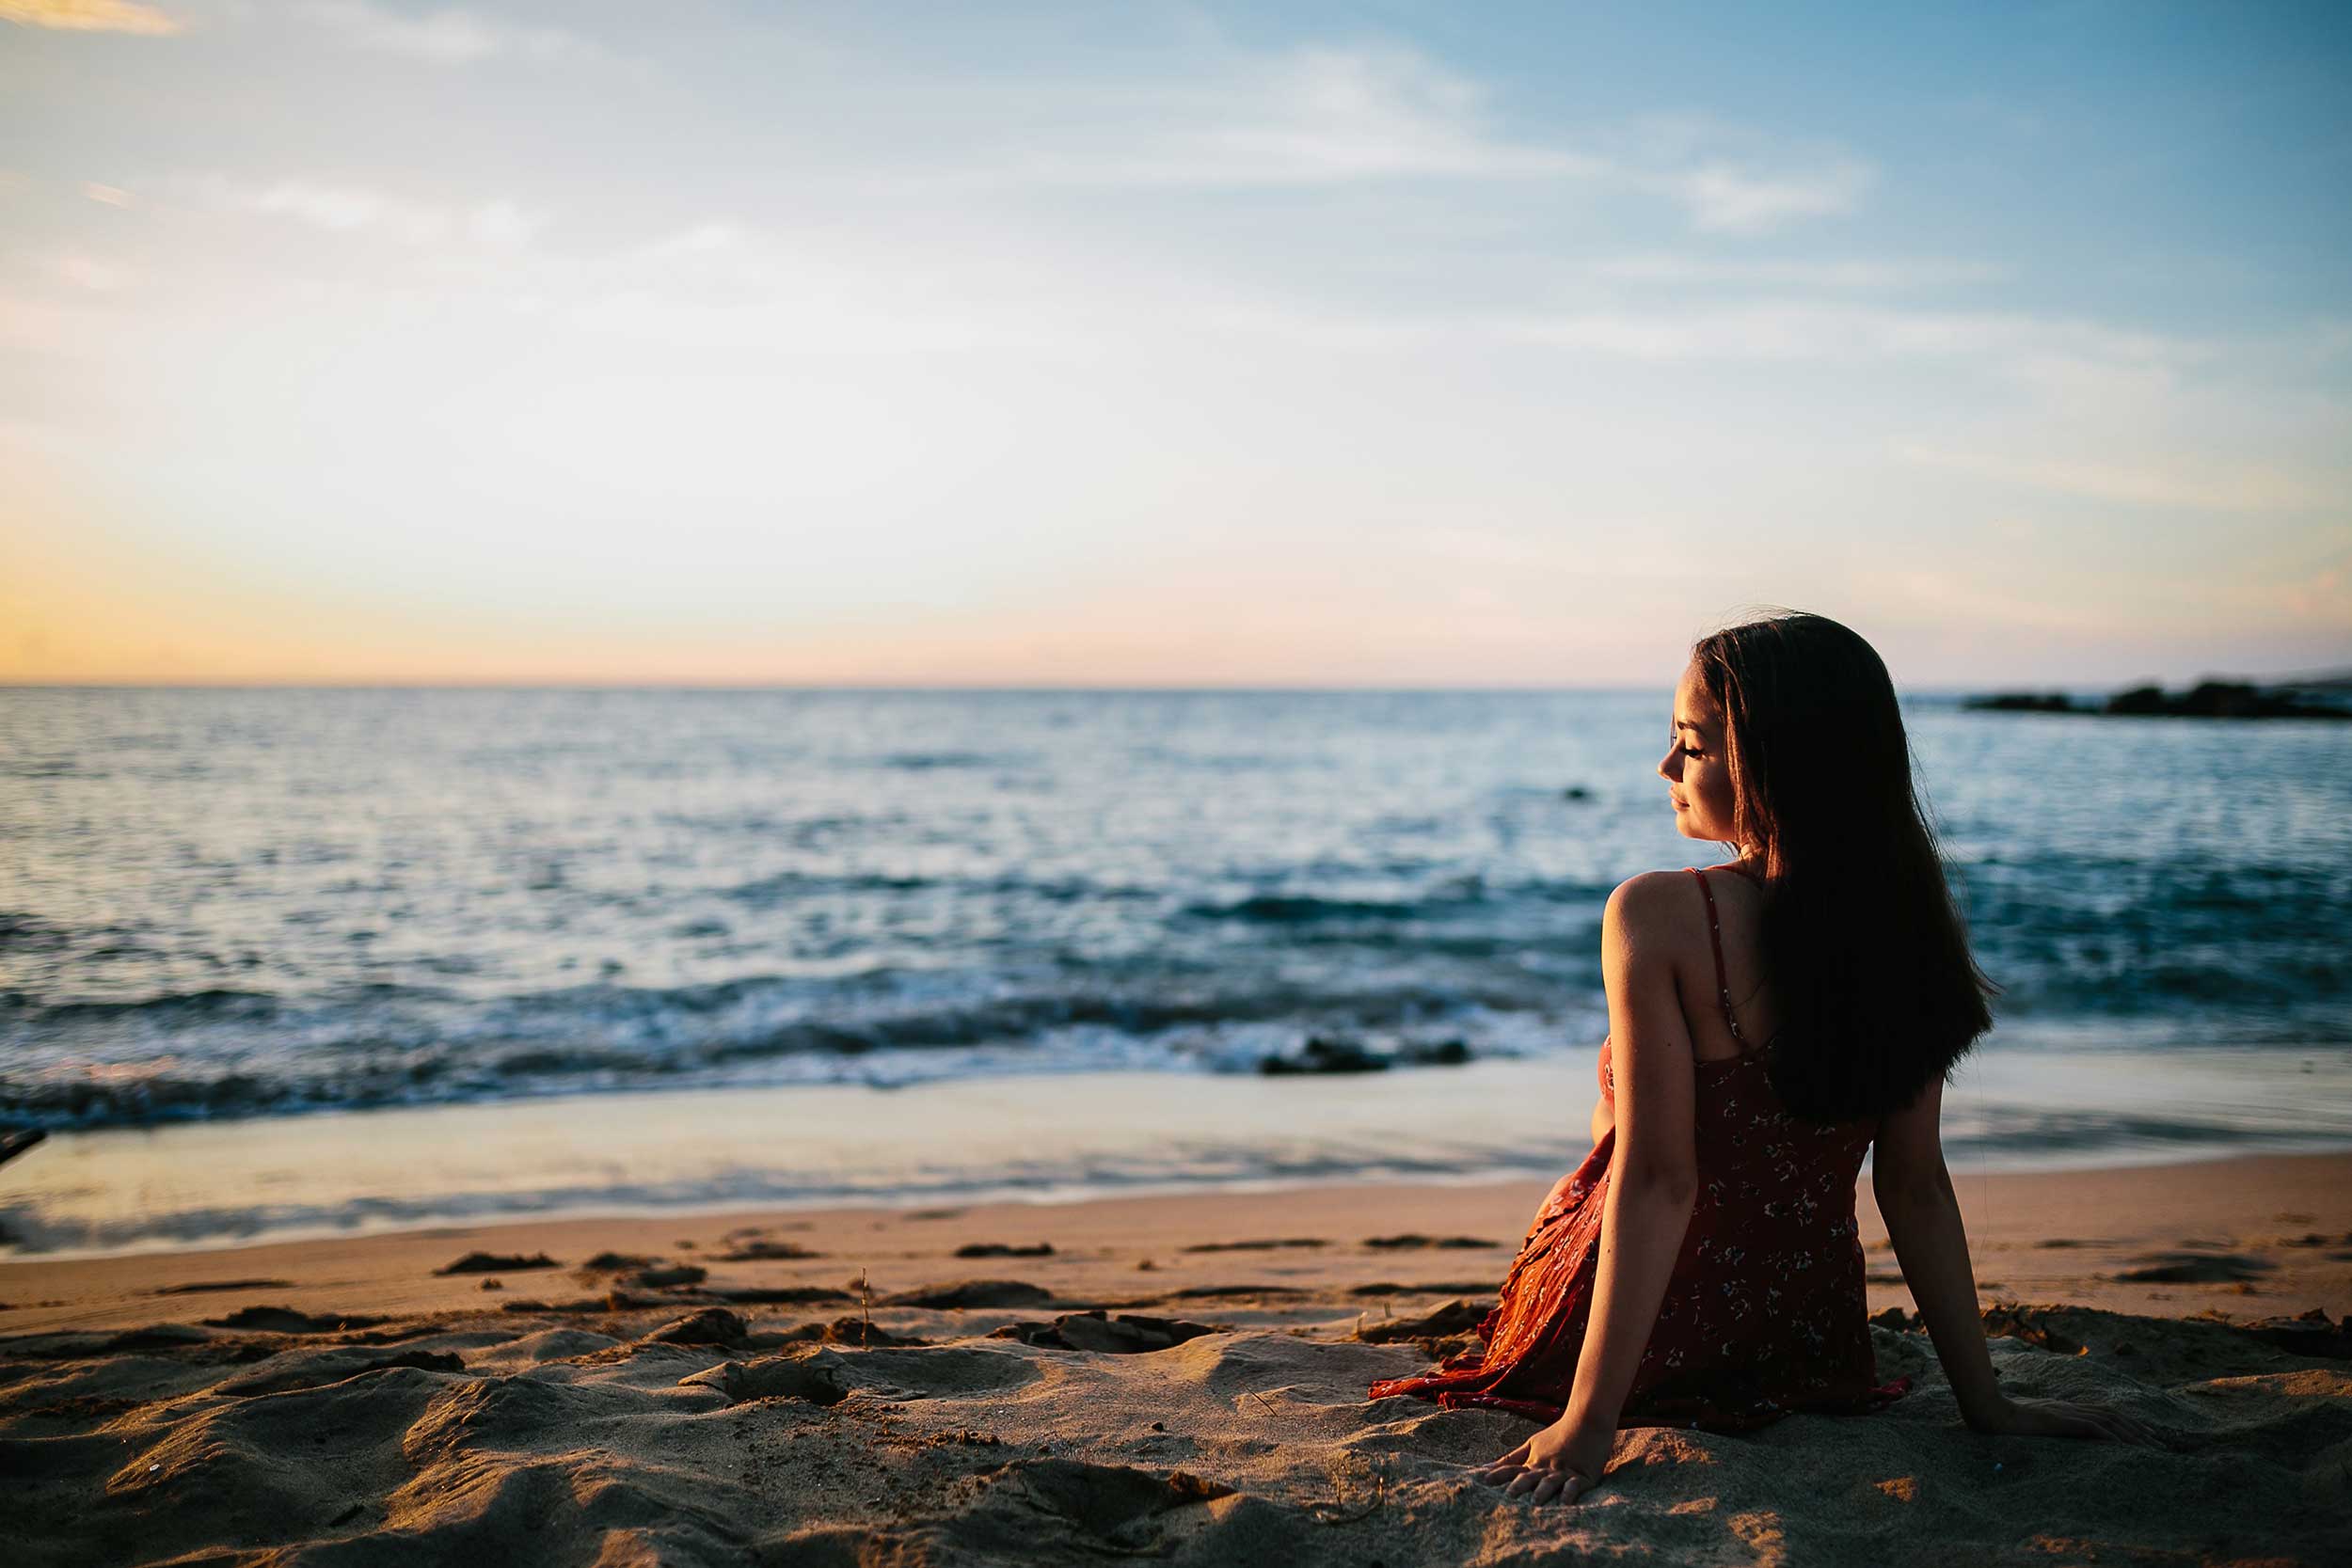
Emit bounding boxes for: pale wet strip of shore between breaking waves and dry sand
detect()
[0,1051,2352,1262]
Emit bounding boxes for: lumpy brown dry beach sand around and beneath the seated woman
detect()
[0,1154,2352,1568]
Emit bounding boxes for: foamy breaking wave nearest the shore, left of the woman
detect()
[0,974,1590,1129]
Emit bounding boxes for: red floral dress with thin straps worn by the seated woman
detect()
[1372,867,1910,1432]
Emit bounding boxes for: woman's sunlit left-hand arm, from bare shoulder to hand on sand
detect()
[1489,872,1698,1502]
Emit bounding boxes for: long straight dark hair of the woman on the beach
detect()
[1692,611,2002,1124]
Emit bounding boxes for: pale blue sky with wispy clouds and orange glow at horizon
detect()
[0,0,2352,689]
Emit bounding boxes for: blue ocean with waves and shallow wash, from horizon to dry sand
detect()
[0,687,2352,1253]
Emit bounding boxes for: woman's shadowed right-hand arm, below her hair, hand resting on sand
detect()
[1870,1079,2162,1444]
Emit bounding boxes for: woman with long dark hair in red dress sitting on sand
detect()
[1372,613,2148,1502]
